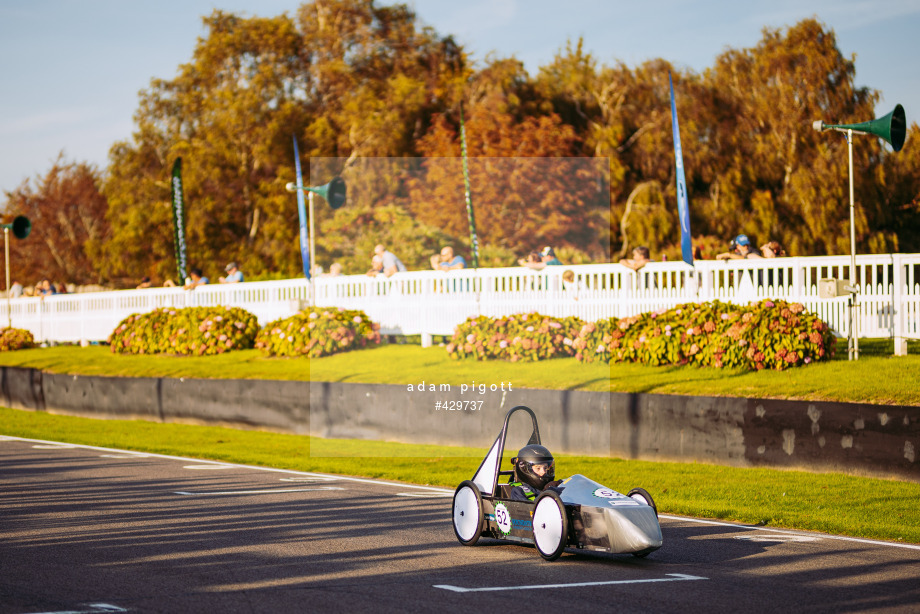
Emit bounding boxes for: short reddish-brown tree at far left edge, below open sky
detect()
[6,153,109,285]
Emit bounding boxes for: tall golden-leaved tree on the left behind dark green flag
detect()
[99,11,308,286]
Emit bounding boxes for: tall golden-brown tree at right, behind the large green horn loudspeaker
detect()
[701,19,891,254]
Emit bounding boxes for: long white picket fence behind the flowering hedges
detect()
[7,254,920,353]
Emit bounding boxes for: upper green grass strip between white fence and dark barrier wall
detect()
[0,340,920,406]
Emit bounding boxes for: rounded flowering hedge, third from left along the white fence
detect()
[256,307,380,358]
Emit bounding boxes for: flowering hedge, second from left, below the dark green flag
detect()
[108,307,259,356]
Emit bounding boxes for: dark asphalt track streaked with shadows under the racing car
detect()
[0,437,920,614]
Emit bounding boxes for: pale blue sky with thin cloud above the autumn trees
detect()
[0,0,920,201]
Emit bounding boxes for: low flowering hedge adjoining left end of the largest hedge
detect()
[447,313,584,362]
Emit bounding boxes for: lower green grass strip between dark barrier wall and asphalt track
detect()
[0,408,920,543]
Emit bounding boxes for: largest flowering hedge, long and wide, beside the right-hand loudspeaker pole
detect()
[575,300,836,370]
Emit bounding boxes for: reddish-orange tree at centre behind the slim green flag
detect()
[410,60,608,264]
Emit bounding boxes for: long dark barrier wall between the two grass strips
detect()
[0,367,920,481]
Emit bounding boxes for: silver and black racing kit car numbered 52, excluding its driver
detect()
[453,405,662,561]
